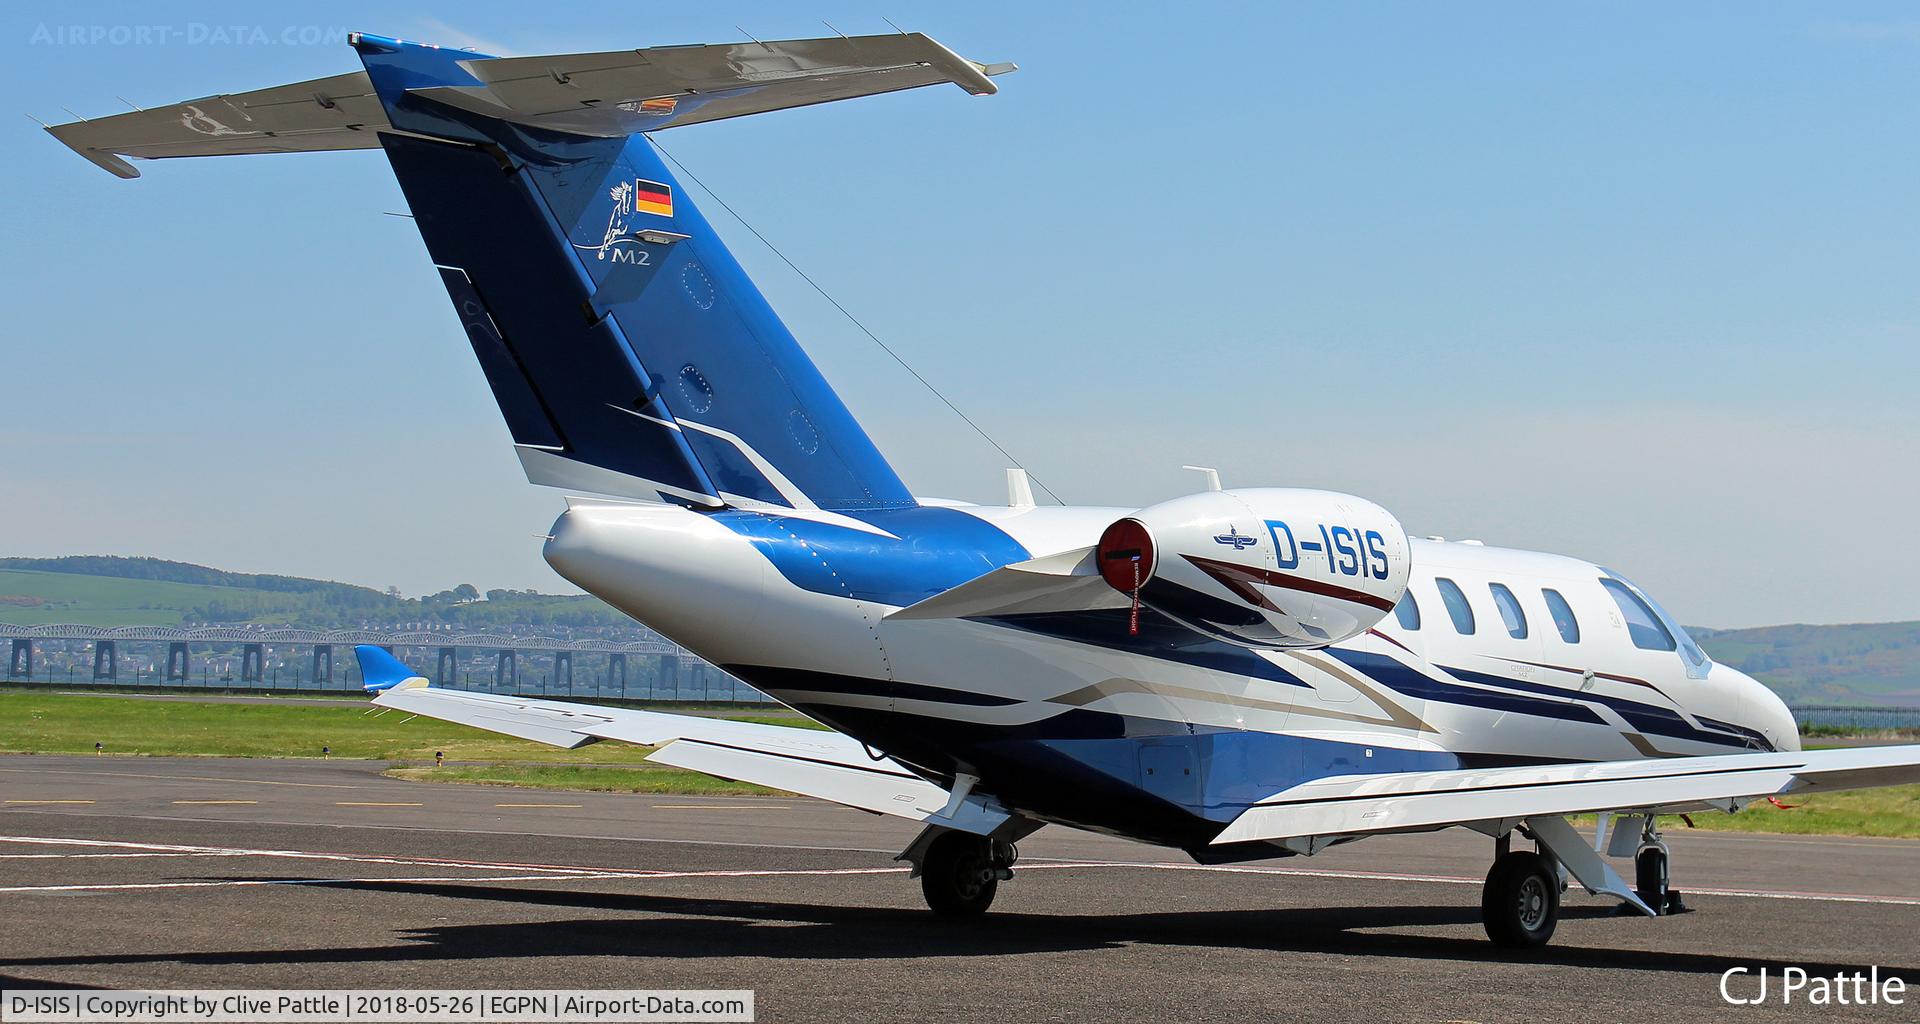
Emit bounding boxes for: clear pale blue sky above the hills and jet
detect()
[0,0,1920,626]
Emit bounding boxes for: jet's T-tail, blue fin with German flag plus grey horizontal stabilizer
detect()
[48,33,1014,511]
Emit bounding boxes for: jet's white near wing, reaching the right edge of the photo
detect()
[1213,745,1920,843]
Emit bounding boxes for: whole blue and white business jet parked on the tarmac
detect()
[48,33,1920,945]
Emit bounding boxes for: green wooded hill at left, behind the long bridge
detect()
[0,555,637,630]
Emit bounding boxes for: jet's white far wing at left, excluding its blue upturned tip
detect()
[372,680,1008,834]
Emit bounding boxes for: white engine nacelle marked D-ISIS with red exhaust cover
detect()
[1094,488,1411,647]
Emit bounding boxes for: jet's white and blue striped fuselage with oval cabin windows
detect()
[545,500,1797,845]
